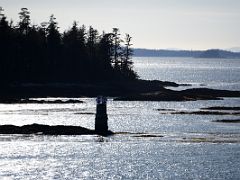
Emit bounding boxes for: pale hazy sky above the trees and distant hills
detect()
[0,0,240,49]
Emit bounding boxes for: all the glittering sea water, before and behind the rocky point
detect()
[0,58,240,179]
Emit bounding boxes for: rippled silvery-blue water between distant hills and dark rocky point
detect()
[134,57,240,90]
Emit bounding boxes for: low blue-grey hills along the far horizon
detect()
[134,48,240,58]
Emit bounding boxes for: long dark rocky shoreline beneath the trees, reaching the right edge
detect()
[0,80,240,103]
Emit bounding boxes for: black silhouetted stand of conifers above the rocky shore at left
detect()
[0,7,137,84]
